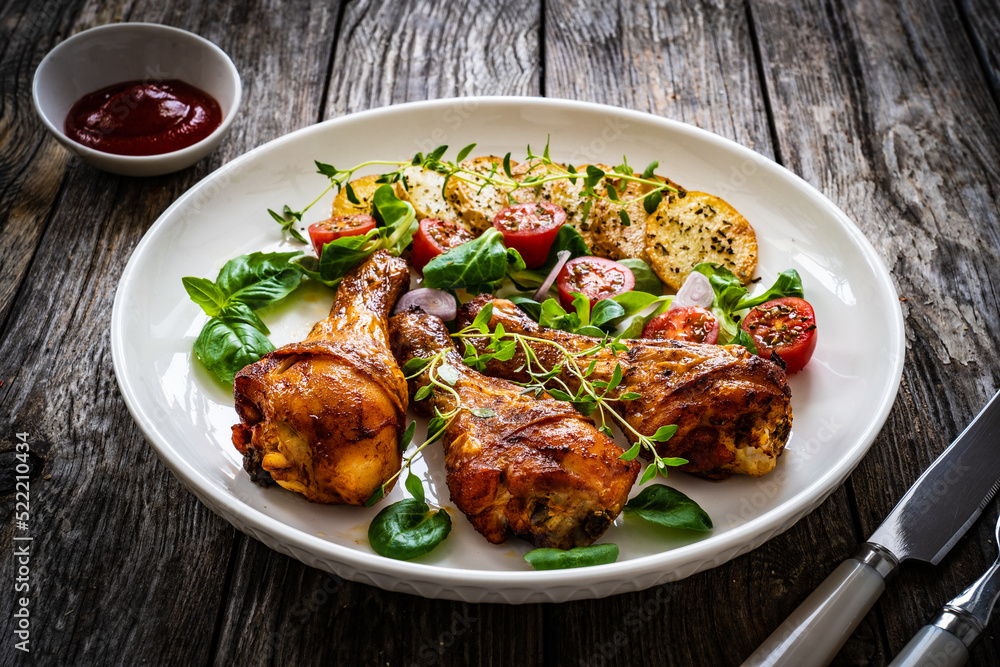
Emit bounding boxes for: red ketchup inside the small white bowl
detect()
[65,79,222,155]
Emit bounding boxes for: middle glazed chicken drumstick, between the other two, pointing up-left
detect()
[390,311,639,549]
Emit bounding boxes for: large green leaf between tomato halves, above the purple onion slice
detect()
[424,227,520,291]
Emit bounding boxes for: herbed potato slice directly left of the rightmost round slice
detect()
[590,170,681,263]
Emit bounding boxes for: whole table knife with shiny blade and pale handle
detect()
[743,392,1000,667]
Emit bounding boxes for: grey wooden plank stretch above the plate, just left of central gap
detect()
[327,0,540,118]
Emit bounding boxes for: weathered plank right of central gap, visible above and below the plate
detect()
[546,2,876,665]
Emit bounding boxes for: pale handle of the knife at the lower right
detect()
[743,544,896,667]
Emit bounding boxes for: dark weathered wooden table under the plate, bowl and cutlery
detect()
[0,0,1000,666]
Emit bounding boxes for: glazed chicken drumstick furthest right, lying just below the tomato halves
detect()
[458,295,792,479]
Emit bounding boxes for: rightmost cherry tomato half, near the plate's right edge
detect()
[740,296,816,373]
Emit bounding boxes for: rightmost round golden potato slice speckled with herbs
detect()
[646,192,757,290]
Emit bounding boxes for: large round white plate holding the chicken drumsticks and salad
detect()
[111,98,904,603]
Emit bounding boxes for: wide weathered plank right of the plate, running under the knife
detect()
[753,1,1000,664]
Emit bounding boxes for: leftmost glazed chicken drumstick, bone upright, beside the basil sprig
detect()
[233,250,410,505]
